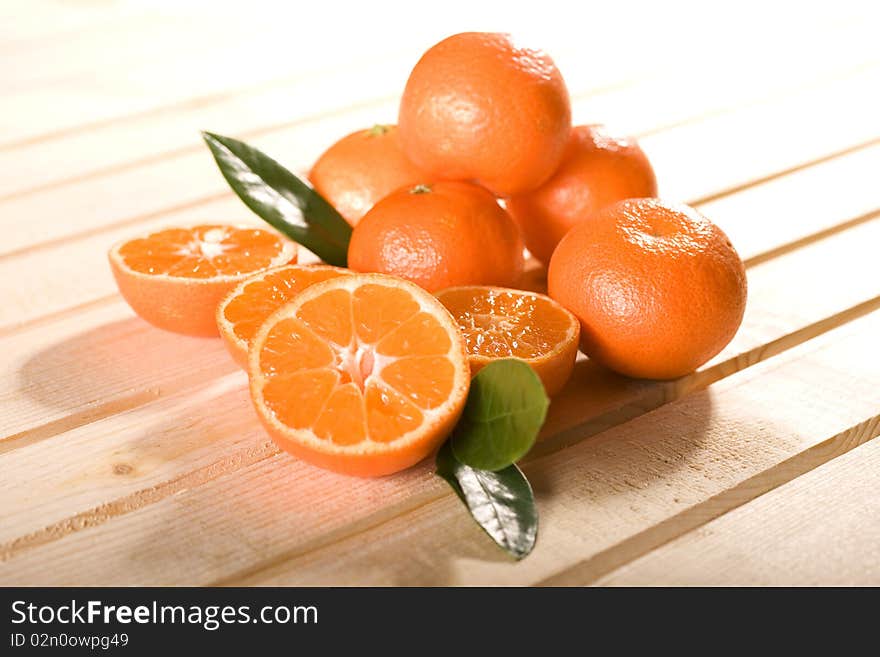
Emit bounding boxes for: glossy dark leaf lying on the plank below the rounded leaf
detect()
[437,440,538,559]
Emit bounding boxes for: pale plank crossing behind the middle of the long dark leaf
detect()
[0,60,880,262]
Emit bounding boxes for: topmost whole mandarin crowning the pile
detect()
[398,32,571,196]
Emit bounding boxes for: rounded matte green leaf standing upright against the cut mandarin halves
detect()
[450,358,550,471]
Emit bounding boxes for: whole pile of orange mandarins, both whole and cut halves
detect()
[110,33,746,476]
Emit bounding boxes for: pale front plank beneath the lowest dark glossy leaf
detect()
[232,313,880,585]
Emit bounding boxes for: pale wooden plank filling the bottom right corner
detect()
[598,440,880,586]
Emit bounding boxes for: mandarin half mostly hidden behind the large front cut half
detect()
[217,265,351,369]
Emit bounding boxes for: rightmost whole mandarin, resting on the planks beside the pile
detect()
[548,199,746,379]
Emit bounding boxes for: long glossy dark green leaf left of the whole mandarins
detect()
[202,132,351,267]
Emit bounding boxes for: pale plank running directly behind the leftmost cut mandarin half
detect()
[0,136,880,330]
